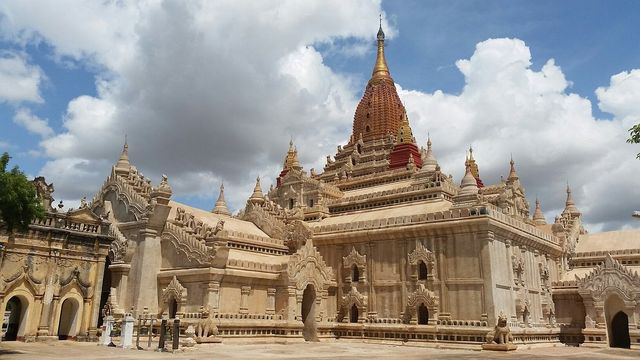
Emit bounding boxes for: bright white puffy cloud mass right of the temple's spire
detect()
[399,39,640,231]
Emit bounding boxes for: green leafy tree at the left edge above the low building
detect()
[0,152,44,233]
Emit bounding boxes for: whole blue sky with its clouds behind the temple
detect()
[0,0,640,229]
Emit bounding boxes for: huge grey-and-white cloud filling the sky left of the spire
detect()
[0,0,394,208]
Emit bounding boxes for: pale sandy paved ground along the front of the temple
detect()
[0,340,640,360]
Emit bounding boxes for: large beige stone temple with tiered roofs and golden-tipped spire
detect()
[0,22,640,347]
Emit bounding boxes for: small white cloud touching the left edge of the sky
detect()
[0,51,44,103]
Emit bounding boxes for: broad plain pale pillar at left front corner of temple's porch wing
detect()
[132,228,162,313]
